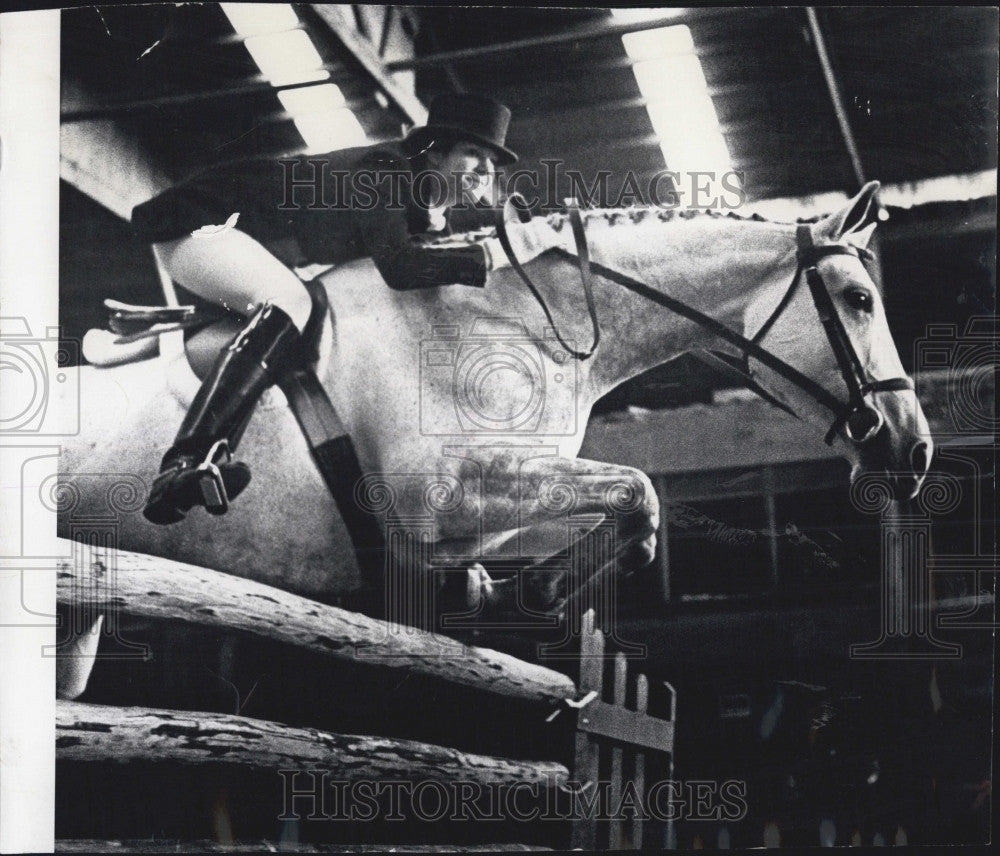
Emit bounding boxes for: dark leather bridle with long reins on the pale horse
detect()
[497,195,913,446]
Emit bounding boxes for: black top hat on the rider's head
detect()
[403,94,517,166]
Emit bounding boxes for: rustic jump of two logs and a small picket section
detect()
[56,540,675,852]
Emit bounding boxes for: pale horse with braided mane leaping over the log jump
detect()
[54,182,933,696]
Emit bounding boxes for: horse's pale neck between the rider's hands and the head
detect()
[558,216,795,395]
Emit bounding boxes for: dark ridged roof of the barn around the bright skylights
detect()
[64,3,998,198]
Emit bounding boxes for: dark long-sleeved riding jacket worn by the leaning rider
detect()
[132,144,492,291]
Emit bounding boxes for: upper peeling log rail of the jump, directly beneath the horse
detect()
[57,539,577,704]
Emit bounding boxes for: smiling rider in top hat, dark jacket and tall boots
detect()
[132,94,555,524]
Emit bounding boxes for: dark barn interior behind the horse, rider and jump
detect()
[56,3,998,849]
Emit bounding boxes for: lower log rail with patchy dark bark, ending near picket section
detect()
[56,701,569,787]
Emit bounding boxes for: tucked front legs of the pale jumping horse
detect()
[369,454,659,611]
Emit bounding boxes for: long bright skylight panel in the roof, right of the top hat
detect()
[622,24,732,176]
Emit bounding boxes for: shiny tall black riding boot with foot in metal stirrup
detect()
[143,283,327,524]
